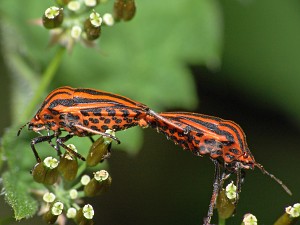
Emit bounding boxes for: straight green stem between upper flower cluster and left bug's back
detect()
[22,47,65,121]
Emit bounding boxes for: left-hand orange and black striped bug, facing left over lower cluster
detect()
[18,87,156,162]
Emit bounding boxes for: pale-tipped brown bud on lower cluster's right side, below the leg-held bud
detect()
[84,170,112,197]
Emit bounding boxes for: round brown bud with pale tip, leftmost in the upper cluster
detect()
[42,6,64,29]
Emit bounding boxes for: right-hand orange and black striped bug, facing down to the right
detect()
[147,112,291,225]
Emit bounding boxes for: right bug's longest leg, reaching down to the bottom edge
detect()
[204,160,221,225]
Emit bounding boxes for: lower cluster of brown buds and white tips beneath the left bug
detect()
[32,133,113,225]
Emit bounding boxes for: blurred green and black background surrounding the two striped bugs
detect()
[0,0,300,225]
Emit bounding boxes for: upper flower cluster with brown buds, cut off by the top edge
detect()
[42,0,136,50]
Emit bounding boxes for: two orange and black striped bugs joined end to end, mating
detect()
[18,87,291,225]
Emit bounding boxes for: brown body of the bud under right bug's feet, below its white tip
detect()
[216,189,235,219]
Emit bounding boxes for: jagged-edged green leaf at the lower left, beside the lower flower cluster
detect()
[2,127,38,220]
